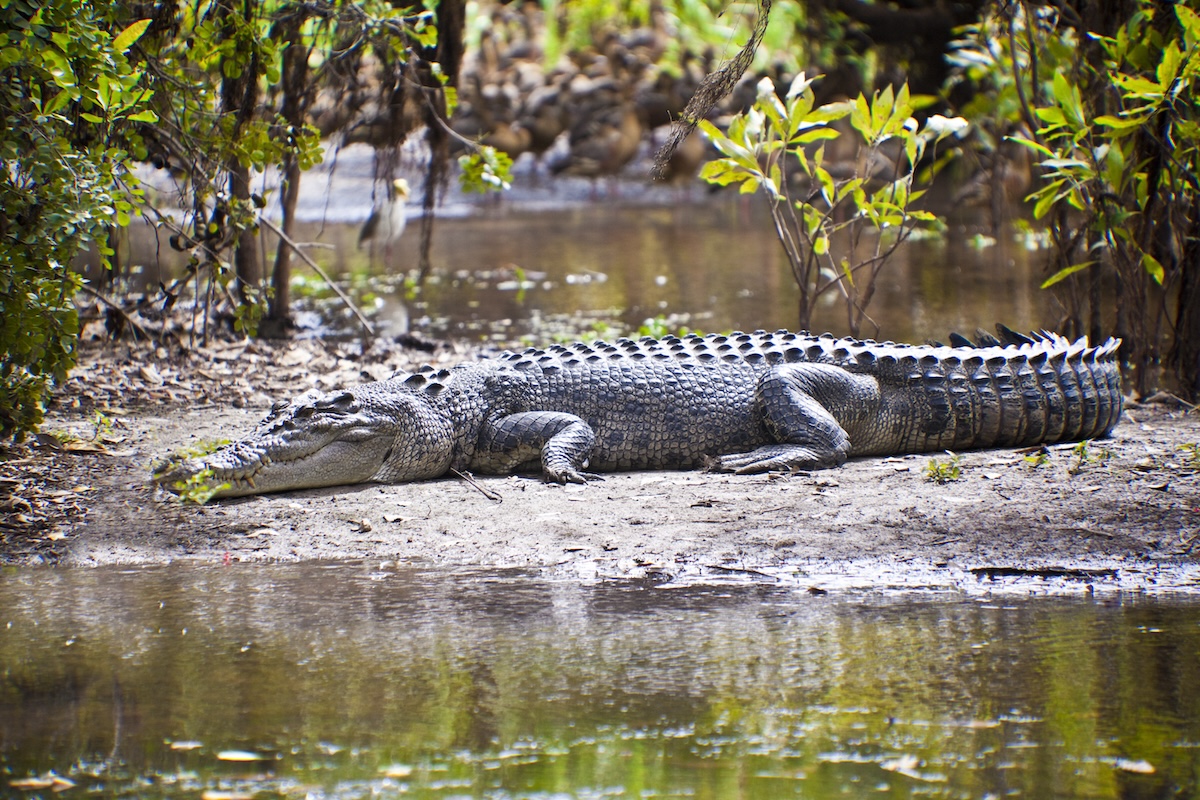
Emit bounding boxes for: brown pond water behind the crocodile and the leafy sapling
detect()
[112,197,1054,342]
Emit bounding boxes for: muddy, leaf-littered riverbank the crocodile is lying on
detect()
[0,333,1200,593]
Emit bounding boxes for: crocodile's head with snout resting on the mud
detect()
[154,381,451,497]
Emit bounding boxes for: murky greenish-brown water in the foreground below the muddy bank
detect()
[0,564,1200,800]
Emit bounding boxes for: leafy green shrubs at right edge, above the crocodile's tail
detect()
[954,0,1200,393]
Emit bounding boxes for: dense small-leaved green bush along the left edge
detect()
[0,0,157,439]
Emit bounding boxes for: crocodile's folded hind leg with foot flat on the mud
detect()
[709,363,878,473]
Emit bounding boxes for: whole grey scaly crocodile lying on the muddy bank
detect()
[155,326,1122,497]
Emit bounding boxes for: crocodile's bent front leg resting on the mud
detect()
[472,411,599,483]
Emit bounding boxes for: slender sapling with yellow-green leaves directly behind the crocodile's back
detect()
[700,73,966,335]
